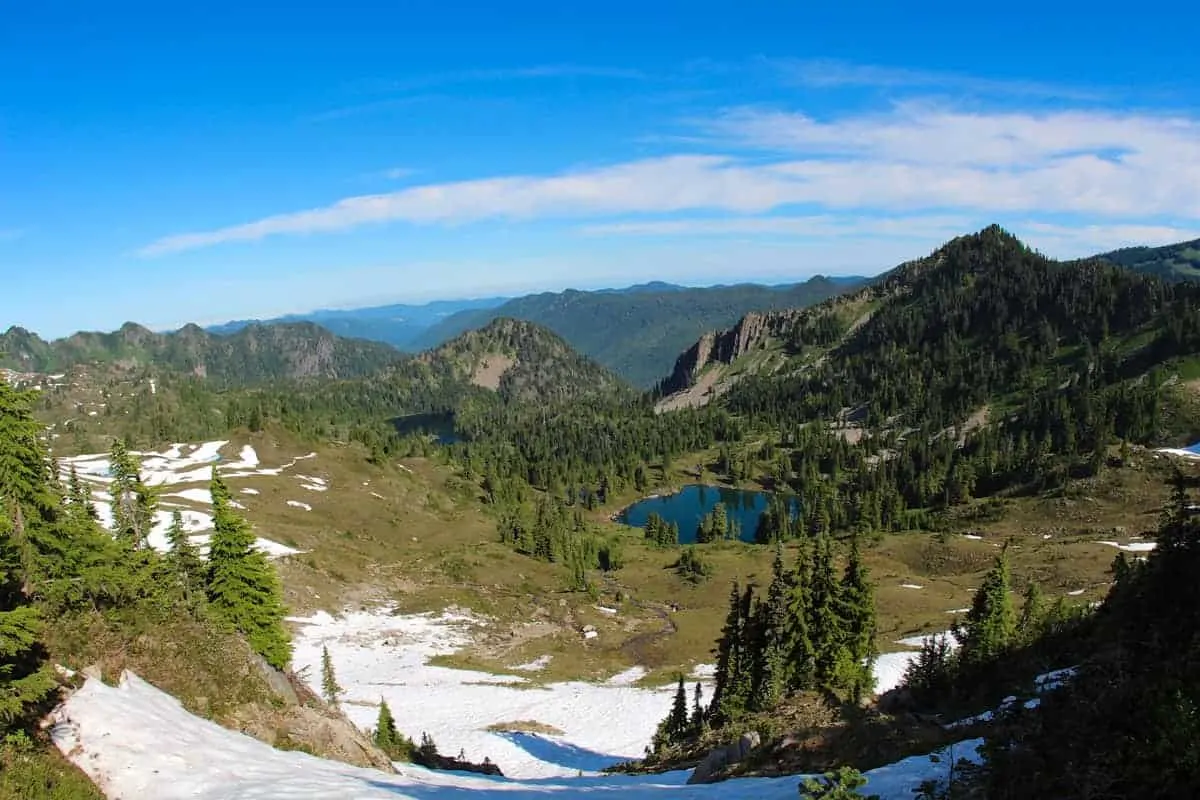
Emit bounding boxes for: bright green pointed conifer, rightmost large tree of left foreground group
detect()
[206,467,292,669]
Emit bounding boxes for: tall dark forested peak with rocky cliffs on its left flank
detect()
[661,225,1200,425]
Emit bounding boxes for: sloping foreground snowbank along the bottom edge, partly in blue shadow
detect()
[52,673,983,800]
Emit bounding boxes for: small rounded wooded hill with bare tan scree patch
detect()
[419,318,631,403]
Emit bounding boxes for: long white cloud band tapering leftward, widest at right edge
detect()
[139,103,1200,255]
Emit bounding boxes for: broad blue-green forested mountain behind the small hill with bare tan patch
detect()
[408,276,860,389]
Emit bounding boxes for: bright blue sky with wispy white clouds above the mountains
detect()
[0,0,1200,336]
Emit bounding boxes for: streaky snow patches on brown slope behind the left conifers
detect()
[59,440,316,558]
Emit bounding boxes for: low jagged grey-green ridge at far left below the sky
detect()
[0,323,402,385]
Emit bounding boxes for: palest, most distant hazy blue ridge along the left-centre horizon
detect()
[205,297,509,351]
